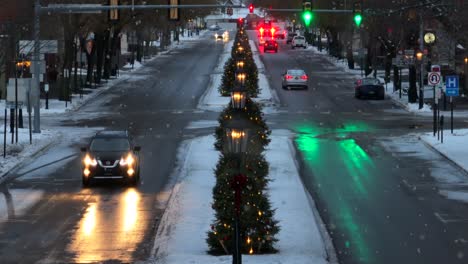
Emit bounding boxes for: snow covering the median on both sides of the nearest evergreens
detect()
[151,130,328,264]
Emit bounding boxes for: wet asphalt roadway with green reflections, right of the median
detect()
[251,35,468,264]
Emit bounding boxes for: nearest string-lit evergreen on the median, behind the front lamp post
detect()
[207,155,280,255]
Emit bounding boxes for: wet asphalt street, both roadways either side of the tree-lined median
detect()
[0,27,468,263]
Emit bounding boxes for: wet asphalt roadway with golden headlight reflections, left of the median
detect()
[0,34,223,263]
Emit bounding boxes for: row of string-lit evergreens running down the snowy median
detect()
[207,30,279,254]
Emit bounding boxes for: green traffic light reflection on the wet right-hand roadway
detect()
[295,123,375,263]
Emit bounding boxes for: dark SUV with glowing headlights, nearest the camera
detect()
[81,131,141,187]
